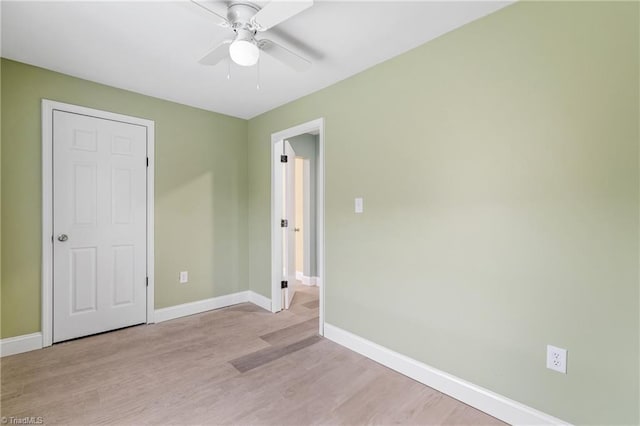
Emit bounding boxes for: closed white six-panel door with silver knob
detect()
[53,111,147,342]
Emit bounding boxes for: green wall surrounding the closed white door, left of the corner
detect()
[1,59,248,338]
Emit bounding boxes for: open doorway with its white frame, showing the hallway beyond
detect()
[271,119,325,335]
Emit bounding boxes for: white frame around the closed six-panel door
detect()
[42,99,155,347]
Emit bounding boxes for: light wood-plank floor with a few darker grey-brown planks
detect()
[0,286,501,425]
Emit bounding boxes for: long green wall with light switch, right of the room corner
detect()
[249,2,640,424]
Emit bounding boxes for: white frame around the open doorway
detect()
[270,118,326,336]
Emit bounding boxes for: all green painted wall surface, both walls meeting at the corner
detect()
[0,2,640,424]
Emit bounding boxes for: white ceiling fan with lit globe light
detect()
[191,0,313,71]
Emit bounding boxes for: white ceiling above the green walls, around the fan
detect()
[1,0,512,118]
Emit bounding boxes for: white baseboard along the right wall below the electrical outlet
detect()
[324,323,568,425]
